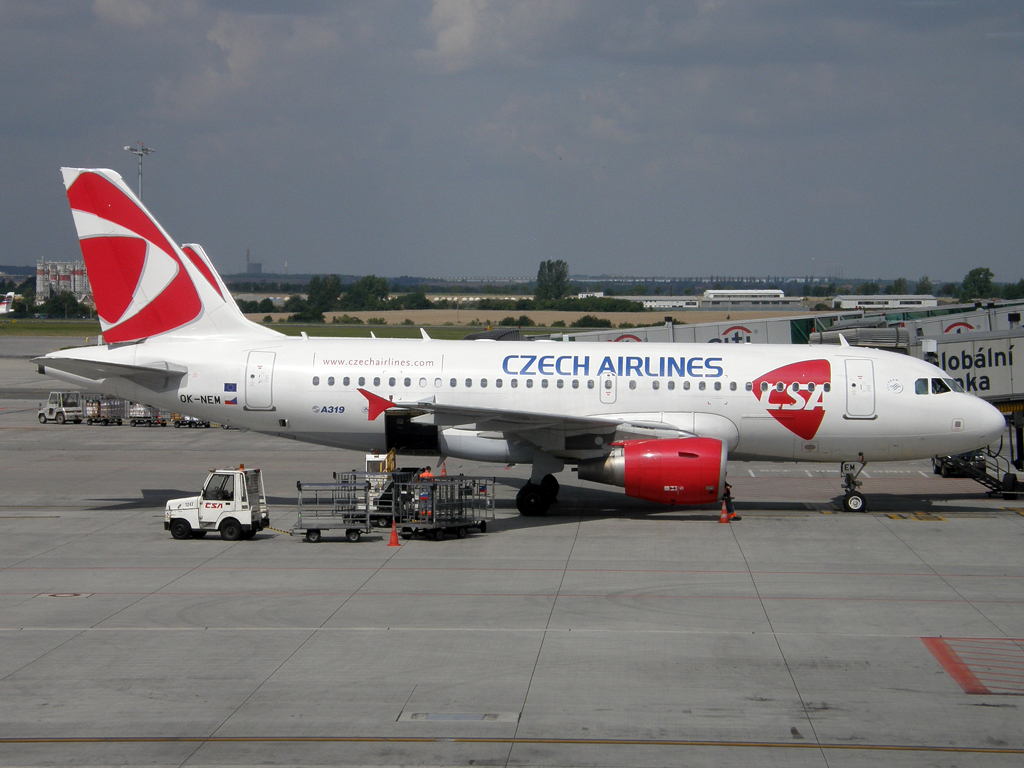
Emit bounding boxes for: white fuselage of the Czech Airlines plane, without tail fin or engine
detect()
[46,336,1002,462]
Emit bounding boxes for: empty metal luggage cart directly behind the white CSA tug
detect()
[291,479,373,542]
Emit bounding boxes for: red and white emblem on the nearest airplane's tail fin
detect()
[65,174,203,342]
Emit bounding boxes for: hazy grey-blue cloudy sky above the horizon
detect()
[0,0,1024,282]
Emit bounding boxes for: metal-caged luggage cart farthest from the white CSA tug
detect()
[393,475,495,541]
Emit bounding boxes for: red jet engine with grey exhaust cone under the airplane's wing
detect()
[579,437,728,505]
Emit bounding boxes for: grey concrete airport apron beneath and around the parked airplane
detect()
[0,339,1024,768]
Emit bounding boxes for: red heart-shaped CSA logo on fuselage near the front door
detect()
[754,360,831,440]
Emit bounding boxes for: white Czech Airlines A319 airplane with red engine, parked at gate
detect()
[34,168,1005,515]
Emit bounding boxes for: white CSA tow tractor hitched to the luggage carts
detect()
[164,465,270,542]
